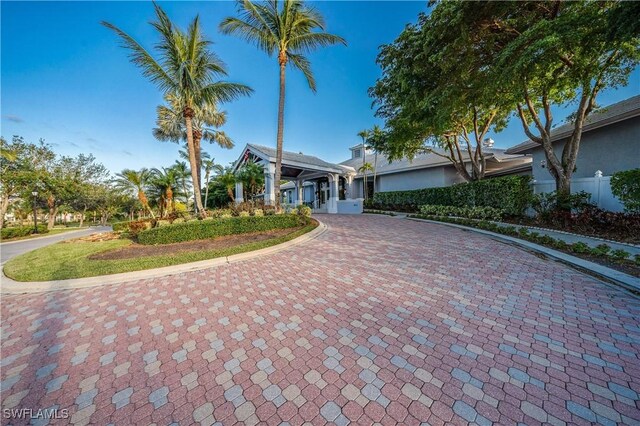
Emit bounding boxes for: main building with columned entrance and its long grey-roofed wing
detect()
[233,144,531,213]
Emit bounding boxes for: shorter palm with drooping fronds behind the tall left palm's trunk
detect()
[152,94,234,188]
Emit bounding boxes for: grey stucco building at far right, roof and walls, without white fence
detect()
[506,95,640,181]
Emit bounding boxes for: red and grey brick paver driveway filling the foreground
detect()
[2,215,640,425]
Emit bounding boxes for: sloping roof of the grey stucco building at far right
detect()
[506,95,640,154]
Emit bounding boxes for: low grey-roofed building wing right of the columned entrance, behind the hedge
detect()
[340,144,531,197]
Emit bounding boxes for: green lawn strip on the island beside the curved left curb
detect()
[4,221,318,281]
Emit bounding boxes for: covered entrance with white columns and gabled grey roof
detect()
[233,144,362,213]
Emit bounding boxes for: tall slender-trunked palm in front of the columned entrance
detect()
[220,0,346,206]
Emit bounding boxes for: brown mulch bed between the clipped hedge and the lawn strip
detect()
[88,226,303,260]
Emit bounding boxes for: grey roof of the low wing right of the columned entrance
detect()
[340,148,523,176]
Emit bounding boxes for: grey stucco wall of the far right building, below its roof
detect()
[531,117,640,180]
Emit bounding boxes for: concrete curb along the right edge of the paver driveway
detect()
[407,218,640,292]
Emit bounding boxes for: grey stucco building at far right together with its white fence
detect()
[506,95,640,211]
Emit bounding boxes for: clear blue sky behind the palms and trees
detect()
[0,1,640,172]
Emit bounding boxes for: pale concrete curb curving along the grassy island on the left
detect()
[0,219,328,294]
